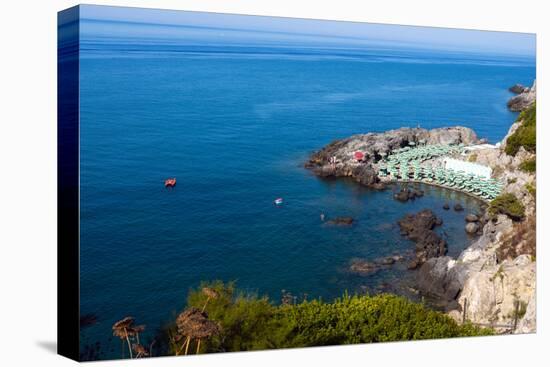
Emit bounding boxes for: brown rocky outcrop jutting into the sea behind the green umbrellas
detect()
[305,126,479,188]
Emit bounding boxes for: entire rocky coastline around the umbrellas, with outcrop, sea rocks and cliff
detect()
[305,83,536,333]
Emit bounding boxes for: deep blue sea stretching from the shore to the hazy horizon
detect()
[72,10,535,357]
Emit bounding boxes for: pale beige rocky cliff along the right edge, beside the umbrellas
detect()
[419,101,536,333]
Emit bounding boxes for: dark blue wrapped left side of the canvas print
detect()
[57,6,79,360]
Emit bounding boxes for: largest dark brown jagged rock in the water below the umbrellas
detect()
[398,209,447,269]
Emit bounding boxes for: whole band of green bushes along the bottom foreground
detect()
[168,282,493,352]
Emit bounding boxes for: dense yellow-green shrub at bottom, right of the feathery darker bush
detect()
[274,294,490,347]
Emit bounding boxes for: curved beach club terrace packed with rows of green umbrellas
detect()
[378,142,503,201]
